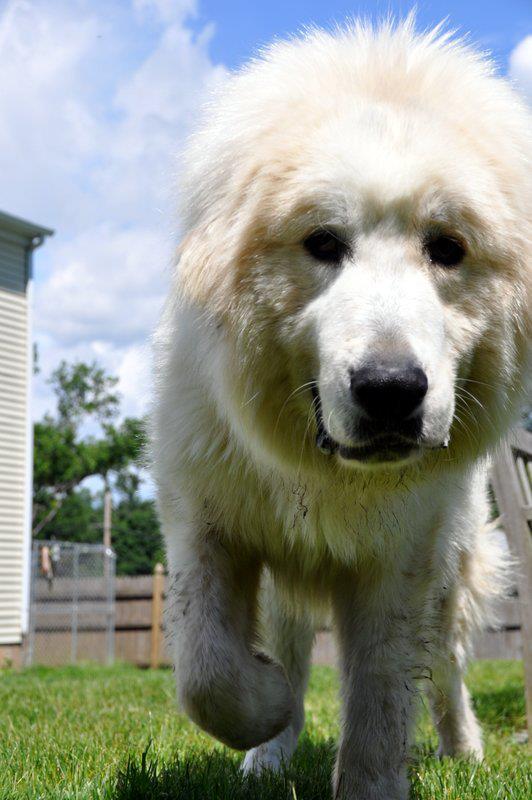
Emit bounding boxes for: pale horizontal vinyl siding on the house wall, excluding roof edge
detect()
[0,233,29,644]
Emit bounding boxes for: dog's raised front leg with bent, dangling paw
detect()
[170,531,294,750]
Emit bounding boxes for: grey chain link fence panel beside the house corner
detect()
[26,541,116,665]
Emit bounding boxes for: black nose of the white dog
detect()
[351,363,429,422]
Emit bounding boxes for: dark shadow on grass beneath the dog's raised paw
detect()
[109,737,334,800]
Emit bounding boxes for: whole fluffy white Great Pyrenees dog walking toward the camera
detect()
[152,21,532,800]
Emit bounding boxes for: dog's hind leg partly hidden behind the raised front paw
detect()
[242,580,314,773]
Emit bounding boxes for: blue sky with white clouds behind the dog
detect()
[0,0,532,432]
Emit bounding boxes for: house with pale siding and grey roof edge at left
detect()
[0,211,53,666]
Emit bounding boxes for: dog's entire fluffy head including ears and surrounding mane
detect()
[179,25,532,476]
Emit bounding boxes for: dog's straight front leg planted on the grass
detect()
[333,582,416,800]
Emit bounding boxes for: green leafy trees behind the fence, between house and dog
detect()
[33,362,163,575]
